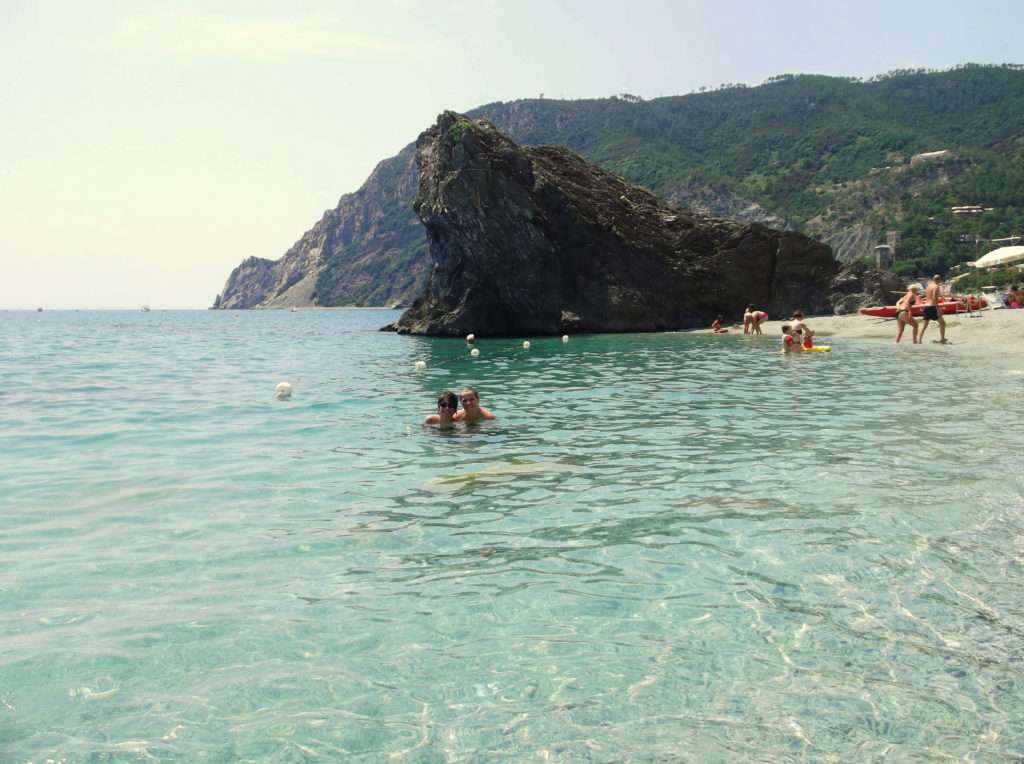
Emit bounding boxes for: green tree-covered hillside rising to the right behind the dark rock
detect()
[473,65,1024,272]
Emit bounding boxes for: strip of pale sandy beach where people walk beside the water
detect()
[698,309,1024,362]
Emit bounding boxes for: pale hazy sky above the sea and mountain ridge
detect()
[0,0,1024,308]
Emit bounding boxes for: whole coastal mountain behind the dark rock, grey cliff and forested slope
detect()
[216,65,1024,307]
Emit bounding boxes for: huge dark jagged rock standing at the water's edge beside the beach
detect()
[388,112,838,336]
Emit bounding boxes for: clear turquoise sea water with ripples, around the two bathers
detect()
[0,310,1024,762]
